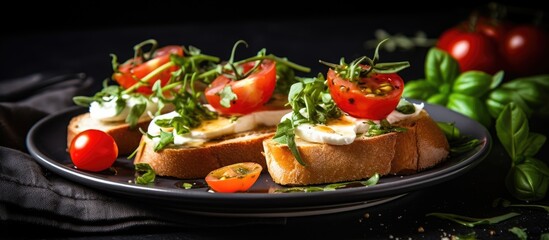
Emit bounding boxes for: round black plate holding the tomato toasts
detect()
[27,104,492,216]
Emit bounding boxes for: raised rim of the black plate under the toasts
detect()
[26,103,493,212]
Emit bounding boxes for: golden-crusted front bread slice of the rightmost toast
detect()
[263,133,397,186]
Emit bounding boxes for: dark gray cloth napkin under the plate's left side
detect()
[0,74,285,236]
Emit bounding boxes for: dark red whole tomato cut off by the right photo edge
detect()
[500,25,549,76]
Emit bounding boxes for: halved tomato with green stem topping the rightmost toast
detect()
[321,40,410,120]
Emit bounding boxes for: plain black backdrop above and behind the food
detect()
[0,1,547,85]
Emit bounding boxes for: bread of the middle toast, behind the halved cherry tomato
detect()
[134,127,276,179]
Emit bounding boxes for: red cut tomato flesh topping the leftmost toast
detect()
[113,45,183,94]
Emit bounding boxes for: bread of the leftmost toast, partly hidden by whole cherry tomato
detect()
[67,112,151,155]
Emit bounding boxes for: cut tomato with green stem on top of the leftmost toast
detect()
[112,40,183,94]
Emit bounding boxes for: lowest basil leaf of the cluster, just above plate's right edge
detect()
[446,93,492,128]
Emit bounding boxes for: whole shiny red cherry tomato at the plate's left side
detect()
[69,129,118,172]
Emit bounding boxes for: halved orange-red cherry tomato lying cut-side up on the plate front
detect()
[206,162,263,193]
